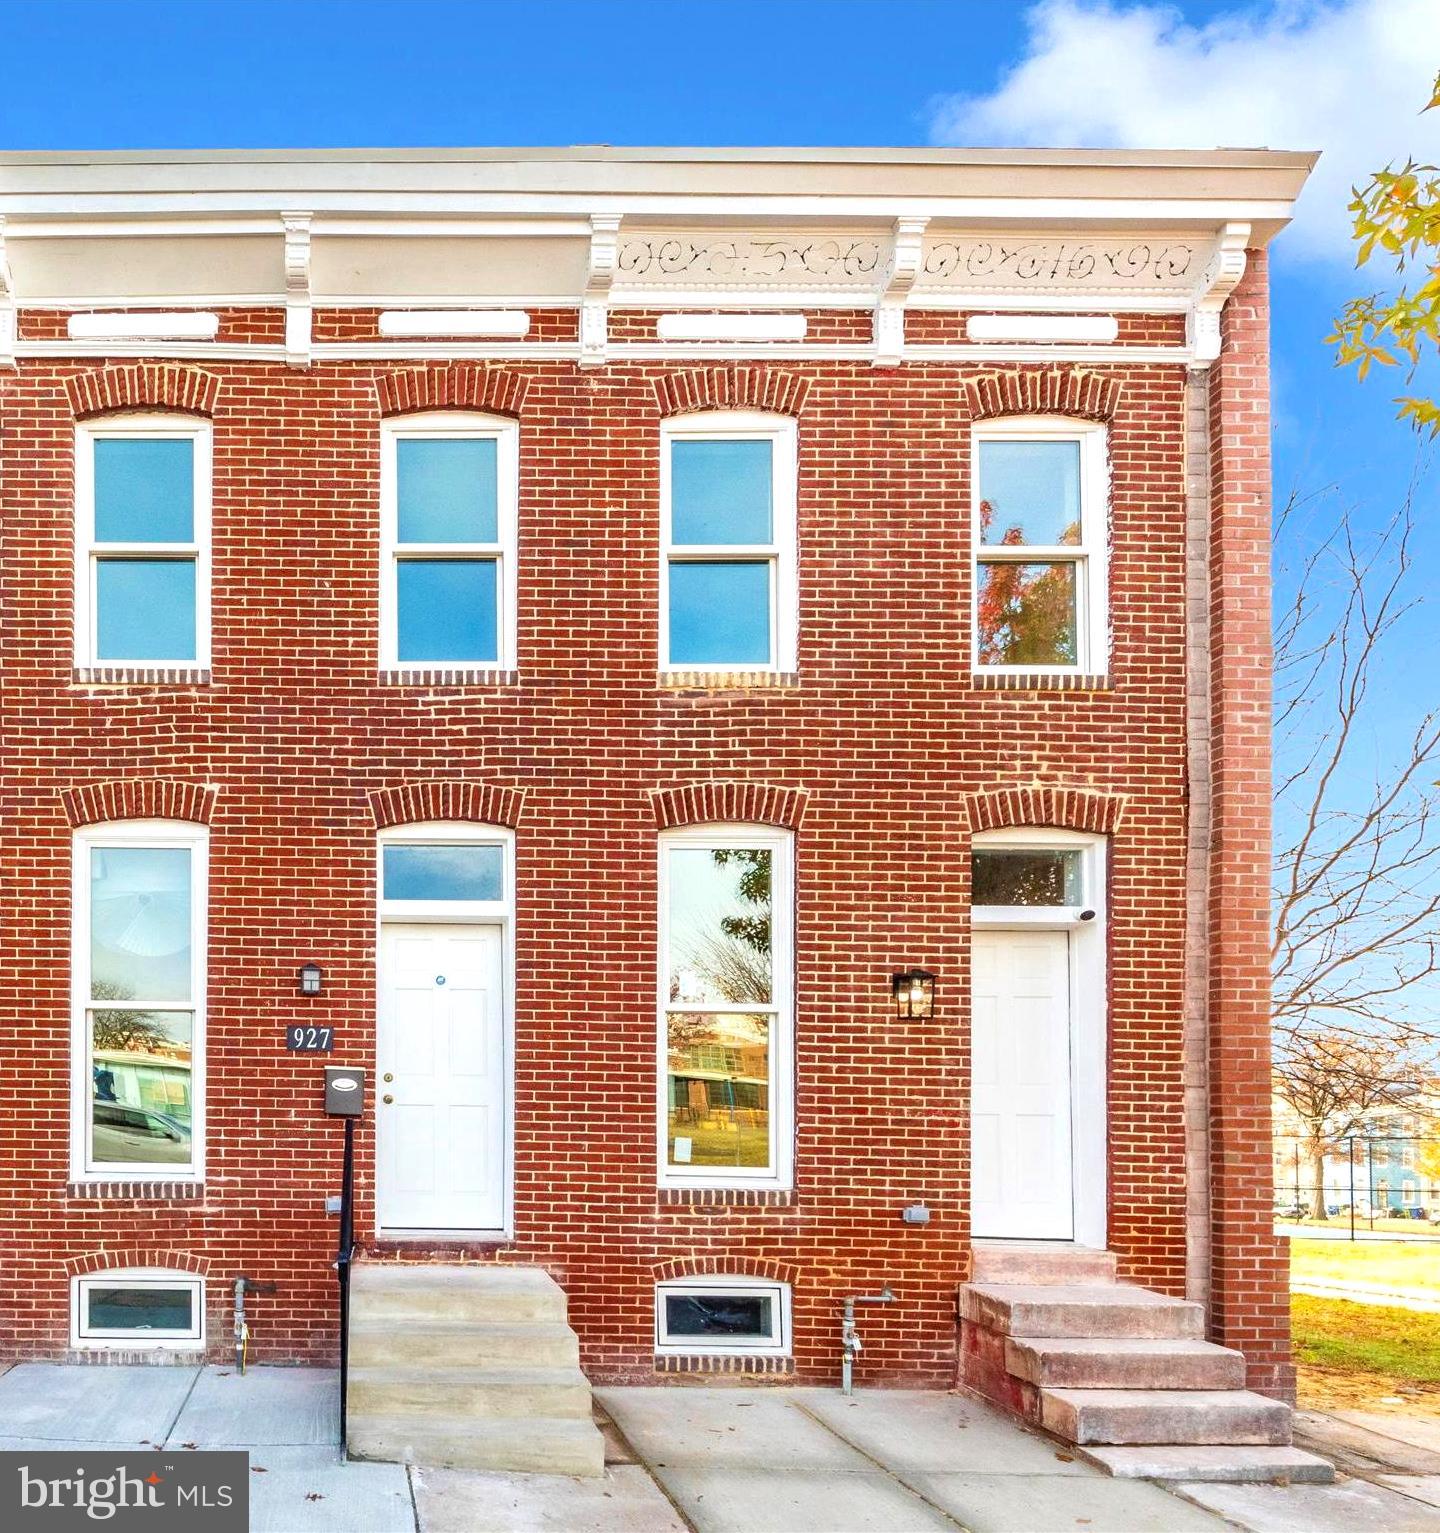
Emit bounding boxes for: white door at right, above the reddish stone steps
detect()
[971,931,1075,1240]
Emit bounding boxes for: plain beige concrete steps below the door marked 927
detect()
[347,1262,604,1476]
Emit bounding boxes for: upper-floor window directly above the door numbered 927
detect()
[380,414,520,670]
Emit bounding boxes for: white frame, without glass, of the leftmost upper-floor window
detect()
[75,414,215,671]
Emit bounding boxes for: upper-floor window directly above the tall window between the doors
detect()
[659,411,796,671]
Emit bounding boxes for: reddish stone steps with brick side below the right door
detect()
[958,1243,1334,1482]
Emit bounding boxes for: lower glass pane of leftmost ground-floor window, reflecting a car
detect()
[89,1007,195,1167]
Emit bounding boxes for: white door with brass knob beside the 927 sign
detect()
[376,923,508,1231]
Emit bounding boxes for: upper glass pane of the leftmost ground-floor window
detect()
[90,846,192,1001]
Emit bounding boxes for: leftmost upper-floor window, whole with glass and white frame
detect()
[75,415,210,667]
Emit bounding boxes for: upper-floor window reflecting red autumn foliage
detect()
[972,417,1109,673]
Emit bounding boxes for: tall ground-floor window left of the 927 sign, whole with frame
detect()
[72,820,205,1180]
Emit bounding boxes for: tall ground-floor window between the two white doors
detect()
[659,825,793,1187]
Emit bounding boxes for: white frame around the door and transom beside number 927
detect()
[374,820,517,1240]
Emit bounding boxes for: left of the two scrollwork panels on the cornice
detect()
[616,231,886,288]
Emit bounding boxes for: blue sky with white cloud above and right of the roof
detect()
[0,0,1440,827]
